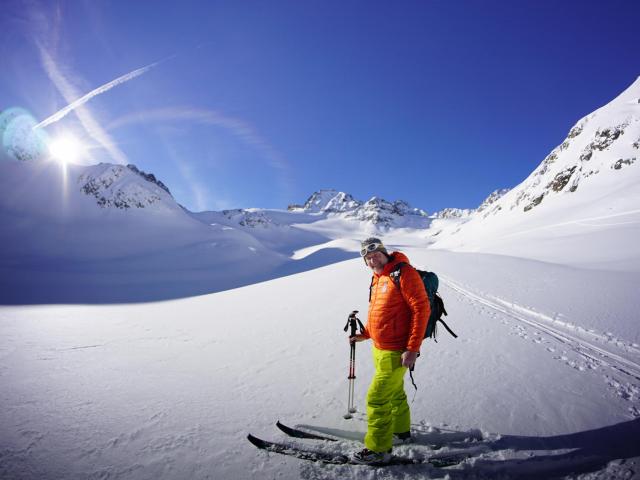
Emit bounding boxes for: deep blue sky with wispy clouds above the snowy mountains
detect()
[0,0,640,212]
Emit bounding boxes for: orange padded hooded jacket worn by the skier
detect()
[364,252,431,352]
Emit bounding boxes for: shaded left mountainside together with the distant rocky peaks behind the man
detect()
[0,156,436,303]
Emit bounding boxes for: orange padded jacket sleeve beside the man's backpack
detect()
[400,267,431,352]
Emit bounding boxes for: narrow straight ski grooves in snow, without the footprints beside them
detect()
[440,276,640,381]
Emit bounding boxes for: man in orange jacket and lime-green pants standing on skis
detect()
[350,237,430,464]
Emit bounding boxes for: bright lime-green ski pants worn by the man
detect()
[364,347,411,452]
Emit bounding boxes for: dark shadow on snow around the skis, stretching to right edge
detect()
[302,418,640,479]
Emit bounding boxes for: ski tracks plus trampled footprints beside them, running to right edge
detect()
[440,276,640,417]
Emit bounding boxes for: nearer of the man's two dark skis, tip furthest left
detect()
[247,434,470,468]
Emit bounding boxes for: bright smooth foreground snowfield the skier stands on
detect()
[0,249,640,480]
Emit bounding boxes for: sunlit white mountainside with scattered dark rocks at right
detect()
[431,75,640,269]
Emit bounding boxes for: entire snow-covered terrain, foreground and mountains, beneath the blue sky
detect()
[0,81,640,480]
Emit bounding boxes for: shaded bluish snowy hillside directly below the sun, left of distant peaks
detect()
[0,162,287,303]
